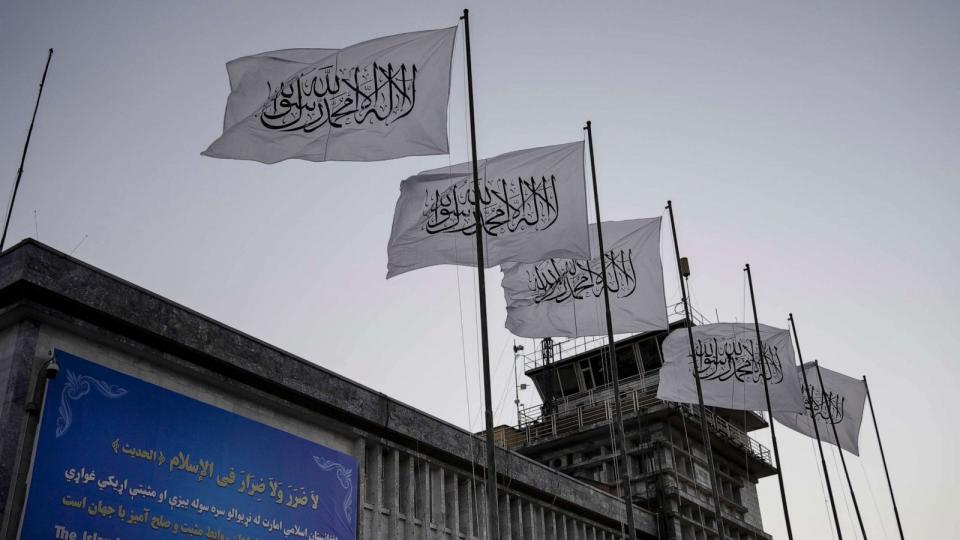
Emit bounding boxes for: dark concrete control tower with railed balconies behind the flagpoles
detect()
[498,330,776,540]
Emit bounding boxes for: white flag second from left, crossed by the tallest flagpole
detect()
[387,142,590,278]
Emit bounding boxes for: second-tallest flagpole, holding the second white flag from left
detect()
[583,120,637,540]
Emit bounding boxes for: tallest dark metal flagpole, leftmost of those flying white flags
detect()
[460,9,500,540]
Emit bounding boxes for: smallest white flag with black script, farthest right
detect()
[773,363,867,456]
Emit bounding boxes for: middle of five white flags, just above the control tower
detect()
[501,217,668,337]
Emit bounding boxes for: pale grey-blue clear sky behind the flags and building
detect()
[0,0,960,539]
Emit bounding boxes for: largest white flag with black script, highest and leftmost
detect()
[203,27,457,163]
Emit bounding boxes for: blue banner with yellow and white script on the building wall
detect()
[21,351,358,540]
